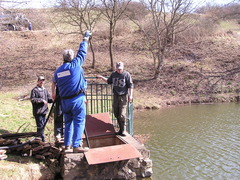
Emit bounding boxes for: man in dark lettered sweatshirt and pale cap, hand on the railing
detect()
[97,62,133,136]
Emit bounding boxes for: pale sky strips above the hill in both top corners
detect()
[2,0,240,8]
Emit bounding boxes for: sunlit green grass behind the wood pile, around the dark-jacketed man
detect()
[0,92,53,140]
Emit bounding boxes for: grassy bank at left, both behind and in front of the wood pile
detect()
[0,90,57,180]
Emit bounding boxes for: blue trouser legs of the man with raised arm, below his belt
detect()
[62,93,86,148]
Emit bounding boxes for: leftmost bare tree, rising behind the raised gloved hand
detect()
[53,0,101,68]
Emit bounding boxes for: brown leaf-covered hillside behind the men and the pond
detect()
[0,20,240,108]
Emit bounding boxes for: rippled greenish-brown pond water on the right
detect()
[134,104,240,180]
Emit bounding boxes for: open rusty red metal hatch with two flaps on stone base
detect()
[84,113,142,165]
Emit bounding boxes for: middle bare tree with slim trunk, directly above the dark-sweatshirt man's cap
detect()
[101,0,131,70]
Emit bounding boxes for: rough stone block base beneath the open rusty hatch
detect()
[61,134,152,180]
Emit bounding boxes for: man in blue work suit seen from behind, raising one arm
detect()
[52,31,91,153]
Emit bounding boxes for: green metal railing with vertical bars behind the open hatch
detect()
[86,77,133,135]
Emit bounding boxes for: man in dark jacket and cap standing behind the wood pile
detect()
[30,76,53,142]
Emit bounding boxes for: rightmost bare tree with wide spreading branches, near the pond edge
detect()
[129,0,193,78]
